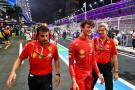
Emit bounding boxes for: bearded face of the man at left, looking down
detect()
[38,32,49,44]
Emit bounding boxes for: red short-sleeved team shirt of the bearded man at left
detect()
[20,40,59,75]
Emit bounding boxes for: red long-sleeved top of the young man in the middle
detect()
[69,37,99,79]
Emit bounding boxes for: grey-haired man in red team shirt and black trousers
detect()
[92,23,118,90]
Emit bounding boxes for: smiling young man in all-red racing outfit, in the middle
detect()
[69,20,104,90]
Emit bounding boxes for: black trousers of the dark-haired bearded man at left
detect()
[28,73,52,90]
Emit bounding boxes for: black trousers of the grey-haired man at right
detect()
[92,62,113,90]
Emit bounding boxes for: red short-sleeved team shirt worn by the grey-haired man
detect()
[94,37,117,64]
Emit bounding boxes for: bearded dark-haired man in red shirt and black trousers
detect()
[7,26,60,90]
